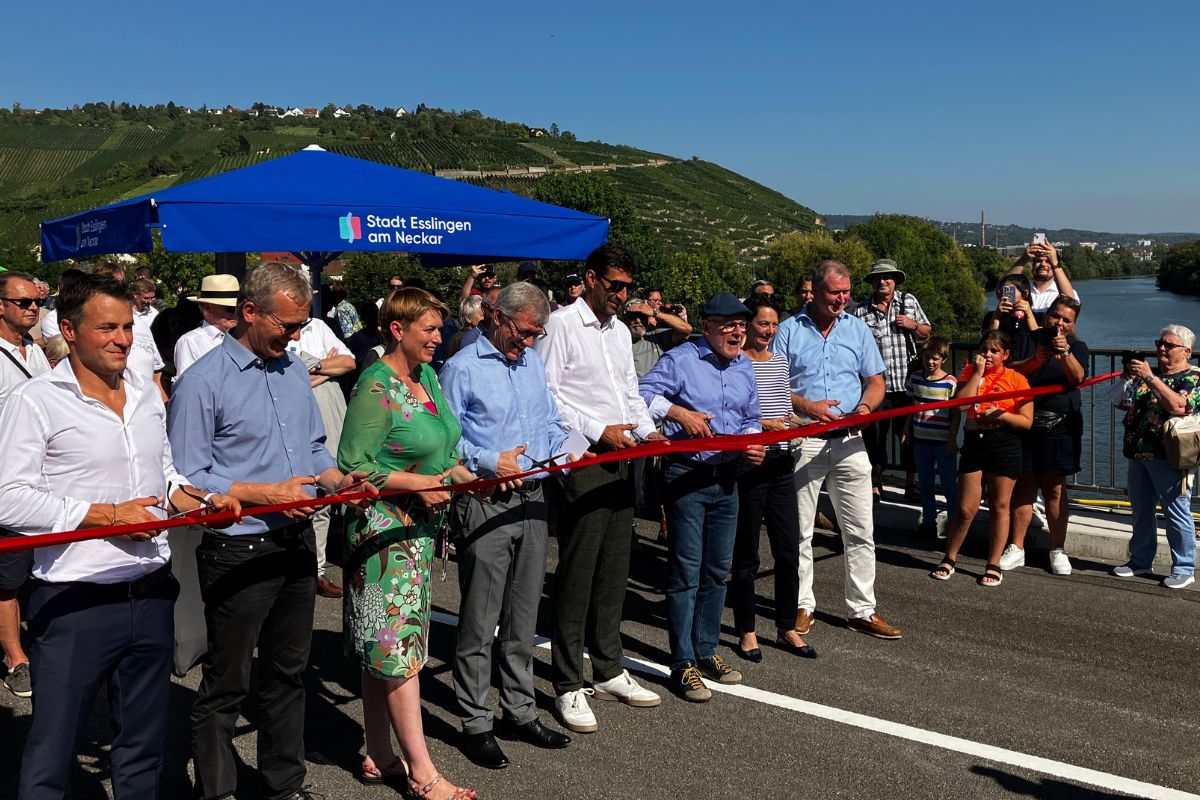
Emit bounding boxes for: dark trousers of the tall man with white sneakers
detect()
[551,462,634,694]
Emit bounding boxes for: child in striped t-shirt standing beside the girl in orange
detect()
[900,336,959,539]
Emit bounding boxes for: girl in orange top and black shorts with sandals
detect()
[929,331,1033,587]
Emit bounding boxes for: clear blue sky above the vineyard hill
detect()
[0,0,1200,233]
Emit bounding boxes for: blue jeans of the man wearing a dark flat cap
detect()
[662,463,738,669]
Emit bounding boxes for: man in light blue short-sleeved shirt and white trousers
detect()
[770,260,900,639]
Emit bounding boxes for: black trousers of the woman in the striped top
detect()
[728,451,800,633]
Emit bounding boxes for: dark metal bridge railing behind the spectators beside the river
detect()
[936,342,1200,503]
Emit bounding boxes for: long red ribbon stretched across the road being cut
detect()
[0,372,1121,553]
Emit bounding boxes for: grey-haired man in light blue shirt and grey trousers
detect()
[439,282,571,769]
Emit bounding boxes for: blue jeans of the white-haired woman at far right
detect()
[1129,458,1196,575]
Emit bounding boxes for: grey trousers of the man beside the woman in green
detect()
[454,481,547,733]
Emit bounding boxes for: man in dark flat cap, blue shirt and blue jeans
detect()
[638,291,766,703]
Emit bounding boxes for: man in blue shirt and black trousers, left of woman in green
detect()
[168,261,374,800]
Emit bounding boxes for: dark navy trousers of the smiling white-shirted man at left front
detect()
[19,567,179,800]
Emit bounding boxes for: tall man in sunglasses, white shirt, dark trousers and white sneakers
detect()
[535,245,662,733]
